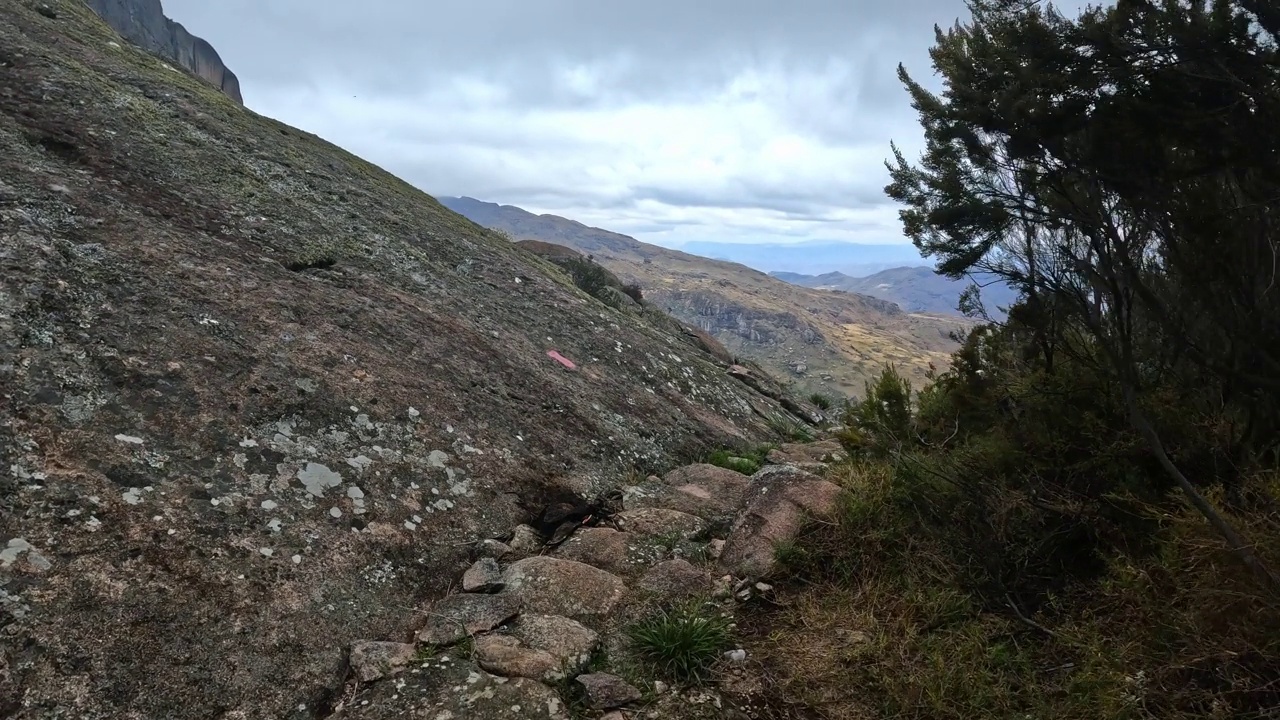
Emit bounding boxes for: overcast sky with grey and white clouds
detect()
[164,0,968,246]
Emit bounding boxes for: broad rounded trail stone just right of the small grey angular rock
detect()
[496,555,627,618]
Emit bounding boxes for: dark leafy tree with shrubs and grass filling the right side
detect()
[747,0,1280,720]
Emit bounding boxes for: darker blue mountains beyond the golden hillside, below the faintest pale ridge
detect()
[769,265,1018,318]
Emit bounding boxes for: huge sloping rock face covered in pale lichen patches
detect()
[0,0,808,720]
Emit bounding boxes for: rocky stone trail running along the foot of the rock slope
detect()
[332,441,842,720]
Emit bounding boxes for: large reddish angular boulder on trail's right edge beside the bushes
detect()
[719,465,844,578]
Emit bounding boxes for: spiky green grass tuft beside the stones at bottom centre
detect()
[627,602,731,683]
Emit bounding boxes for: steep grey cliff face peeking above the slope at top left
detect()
[84,0,244,104]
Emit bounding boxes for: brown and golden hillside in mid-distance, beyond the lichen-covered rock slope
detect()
[440,197,966,396]
